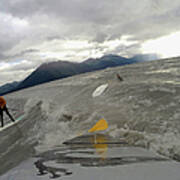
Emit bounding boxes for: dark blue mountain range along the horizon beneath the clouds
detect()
[0,55,157,95]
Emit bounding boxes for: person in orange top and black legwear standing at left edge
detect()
[0,96,15,127]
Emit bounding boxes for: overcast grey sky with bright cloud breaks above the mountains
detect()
[0,0,180,85]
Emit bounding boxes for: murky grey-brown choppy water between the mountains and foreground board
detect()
[0,58,180,178]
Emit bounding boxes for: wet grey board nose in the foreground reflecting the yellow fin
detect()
[0,134,180,180]
